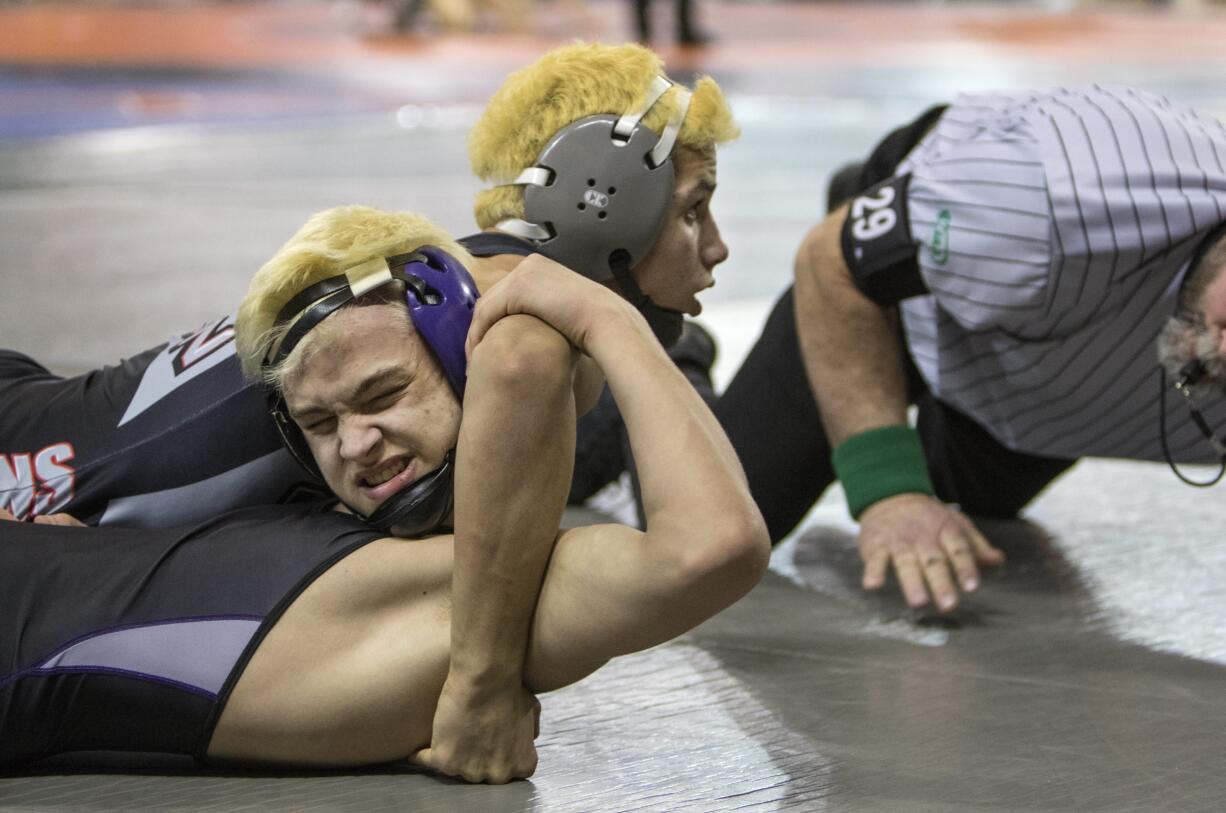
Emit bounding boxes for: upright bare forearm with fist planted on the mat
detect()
[416,314,579,782]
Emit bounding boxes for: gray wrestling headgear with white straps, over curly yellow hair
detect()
[497,76,690,346]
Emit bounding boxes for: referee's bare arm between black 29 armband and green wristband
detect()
[796,206,907,446]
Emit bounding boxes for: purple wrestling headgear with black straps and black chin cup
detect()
[264,245,481,536]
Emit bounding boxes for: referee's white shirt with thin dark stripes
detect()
[899,86,1226,461]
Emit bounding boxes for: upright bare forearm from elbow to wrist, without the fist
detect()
[450,315,575,690]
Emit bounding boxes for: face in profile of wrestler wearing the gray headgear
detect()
[634,147,728,316]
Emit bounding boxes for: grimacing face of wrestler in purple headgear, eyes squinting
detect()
[284,303,460,514]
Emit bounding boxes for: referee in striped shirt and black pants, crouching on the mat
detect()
[717,86,1226,611]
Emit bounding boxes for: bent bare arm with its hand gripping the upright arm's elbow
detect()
[468,256,769,690]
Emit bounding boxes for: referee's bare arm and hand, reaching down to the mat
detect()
[794,205,1004,611]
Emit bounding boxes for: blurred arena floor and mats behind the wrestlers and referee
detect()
[7,0,1226,381]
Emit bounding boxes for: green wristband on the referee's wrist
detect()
[831,427,935,520]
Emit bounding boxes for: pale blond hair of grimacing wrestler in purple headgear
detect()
[234,206,472,385]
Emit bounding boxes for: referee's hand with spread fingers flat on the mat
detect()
[857,494,1004,612]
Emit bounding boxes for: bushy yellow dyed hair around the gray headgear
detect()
[468,43,741,228]
